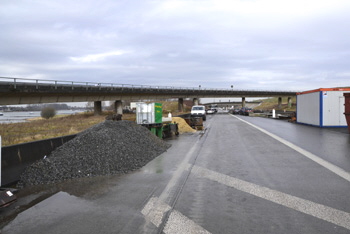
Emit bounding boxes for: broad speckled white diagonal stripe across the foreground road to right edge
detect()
[191,166,350,230]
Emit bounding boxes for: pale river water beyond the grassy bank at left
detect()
[0,110,84,124]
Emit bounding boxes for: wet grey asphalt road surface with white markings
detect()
[1,115,350,234]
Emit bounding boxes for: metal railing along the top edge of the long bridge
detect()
[0,77,297,93]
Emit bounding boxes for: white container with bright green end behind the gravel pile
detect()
[136,103,163,124]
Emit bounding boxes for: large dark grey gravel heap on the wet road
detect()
[18,120,170,187]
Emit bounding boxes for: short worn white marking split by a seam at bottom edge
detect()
[141,197,210,234]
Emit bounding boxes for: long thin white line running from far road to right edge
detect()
[232,115,350,182]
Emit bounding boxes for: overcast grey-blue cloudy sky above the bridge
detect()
[0,0,350,91]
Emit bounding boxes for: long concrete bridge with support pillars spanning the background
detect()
[0,77,296,114]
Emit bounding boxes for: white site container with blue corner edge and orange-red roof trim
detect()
[297,88,350,127]
